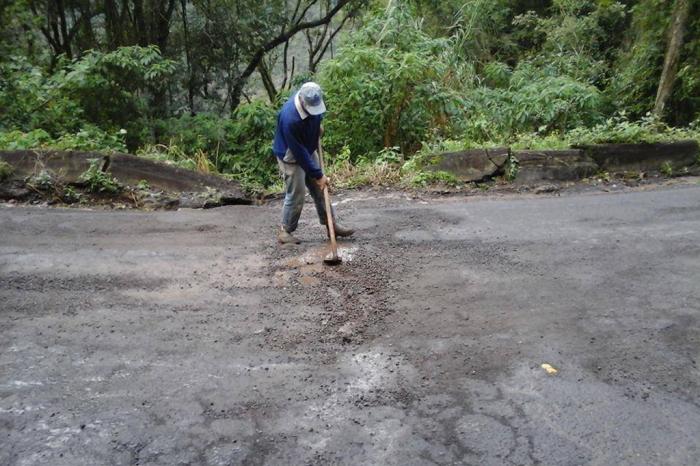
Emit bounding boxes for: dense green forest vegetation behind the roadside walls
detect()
[0,0,700,190]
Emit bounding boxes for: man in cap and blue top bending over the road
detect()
[272,82,354,244]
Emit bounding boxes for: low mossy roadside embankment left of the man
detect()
[0,150,251,209]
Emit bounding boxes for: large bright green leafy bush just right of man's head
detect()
[319,6,459,160]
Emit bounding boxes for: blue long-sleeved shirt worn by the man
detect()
[272,92,323,179]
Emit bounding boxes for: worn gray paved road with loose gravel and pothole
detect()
[0,185,700,466]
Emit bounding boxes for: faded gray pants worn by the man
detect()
[277,151,334,233]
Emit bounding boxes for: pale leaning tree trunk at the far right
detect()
[654,0,690,117]
